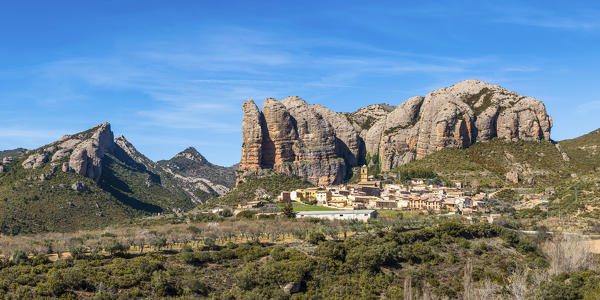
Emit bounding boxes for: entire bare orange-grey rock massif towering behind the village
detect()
[238,80,552,184]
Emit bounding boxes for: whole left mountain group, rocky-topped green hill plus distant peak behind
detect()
[0,123,235,234]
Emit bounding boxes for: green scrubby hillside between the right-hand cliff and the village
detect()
[394,139,576,187]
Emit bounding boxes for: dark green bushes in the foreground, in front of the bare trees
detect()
[0,221,600,299]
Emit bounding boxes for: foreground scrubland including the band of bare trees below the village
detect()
[0,217,600,299]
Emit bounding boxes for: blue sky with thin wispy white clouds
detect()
[0,0,600,165]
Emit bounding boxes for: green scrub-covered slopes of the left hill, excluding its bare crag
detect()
[0,127,195,234]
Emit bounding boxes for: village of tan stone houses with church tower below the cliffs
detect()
[278,166,487,218]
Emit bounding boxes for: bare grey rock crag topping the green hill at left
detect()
[68,123,114,182]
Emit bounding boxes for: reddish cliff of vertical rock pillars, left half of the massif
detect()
[239,97,350,184]
